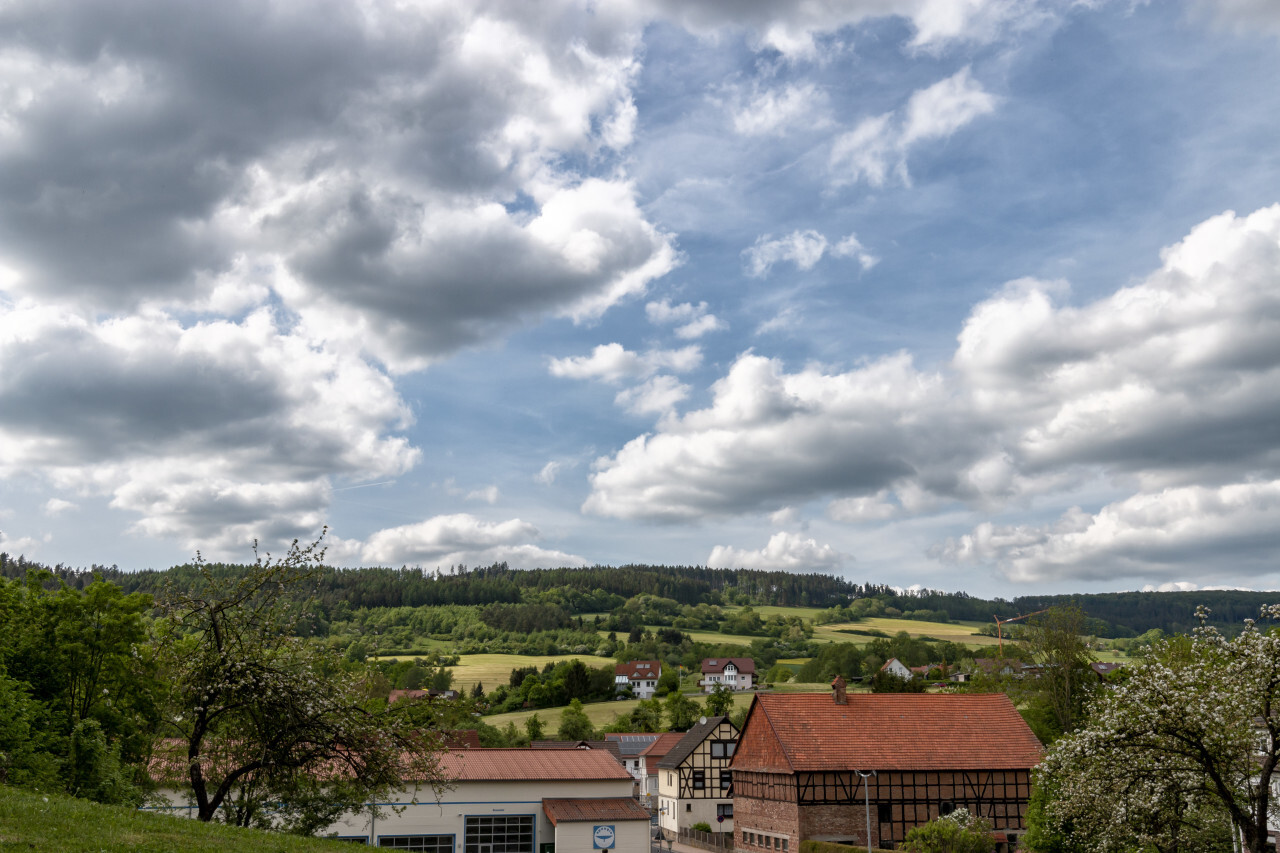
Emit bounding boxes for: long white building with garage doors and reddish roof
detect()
[149,749,649,853]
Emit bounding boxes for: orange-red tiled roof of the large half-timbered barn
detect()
[733,693,1043,771]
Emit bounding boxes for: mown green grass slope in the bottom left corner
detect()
[0,786,351,853]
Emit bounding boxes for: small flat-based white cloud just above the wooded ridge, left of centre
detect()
[360,514,588,569]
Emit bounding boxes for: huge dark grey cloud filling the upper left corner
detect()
[0,0,676,370]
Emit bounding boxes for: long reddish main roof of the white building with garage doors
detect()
[440,749,631,781]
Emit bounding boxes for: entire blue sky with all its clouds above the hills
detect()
[0,0,1280,597]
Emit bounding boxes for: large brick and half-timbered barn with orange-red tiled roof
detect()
[731,678,1042,853]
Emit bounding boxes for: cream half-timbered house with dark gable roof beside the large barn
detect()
[658,717,737,838]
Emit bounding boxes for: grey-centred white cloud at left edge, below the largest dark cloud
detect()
[0,305,420,555]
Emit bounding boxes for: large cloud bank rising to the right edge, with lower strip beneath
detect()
[582,205,1280,580]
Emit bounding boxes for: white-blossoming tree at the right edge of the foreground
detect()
[1036,606,1280,853]
